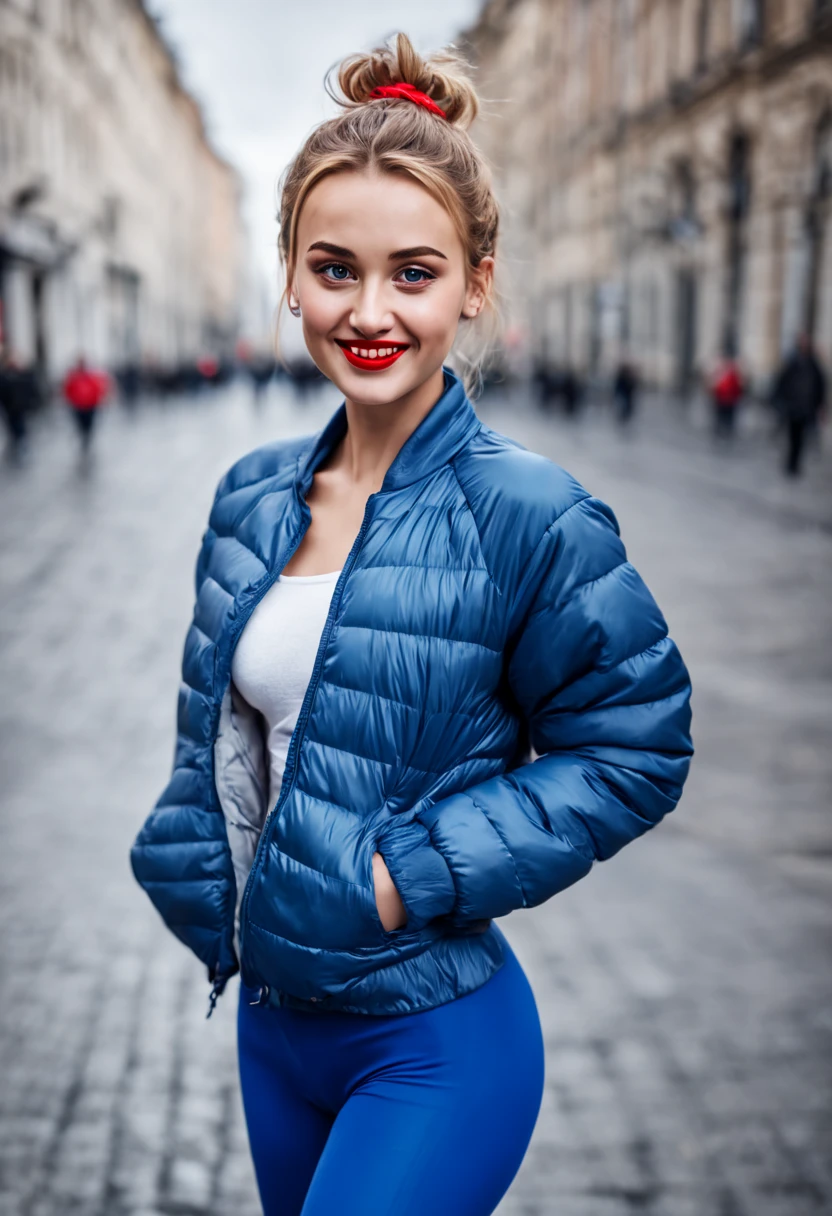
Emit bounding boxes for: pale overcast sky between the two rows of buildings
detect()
[148,0,480,311]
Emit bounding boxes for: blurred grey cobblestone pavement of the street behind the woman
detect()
[0,388,832,1216]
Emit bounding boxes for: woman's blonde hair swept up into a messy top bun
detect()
[279,34,499,387]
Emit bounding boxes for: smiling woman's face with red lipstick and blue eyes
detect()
[291,173,493,405]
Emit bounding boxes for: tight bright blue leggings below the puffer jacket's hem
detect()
[233,941,544,1216]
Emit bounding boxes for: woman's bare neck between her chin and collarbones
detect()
[328,367,445,494]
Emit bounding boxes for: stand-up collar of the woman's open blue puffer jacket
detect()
[297,367,480,495]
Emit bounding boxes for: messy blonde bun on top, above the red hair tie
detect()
[330,34,479,130]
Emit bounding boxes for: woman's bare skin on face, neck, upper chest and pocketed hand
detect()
[285,173,494,930]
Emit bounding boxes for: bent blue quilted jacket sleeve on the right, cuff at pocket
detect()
[378,496,692,927]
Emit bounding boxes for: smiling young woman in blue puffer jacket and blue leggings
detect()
[133,35,691,1216]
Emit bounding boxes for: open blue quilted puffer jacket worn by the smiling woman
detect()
[131,372,692,1014]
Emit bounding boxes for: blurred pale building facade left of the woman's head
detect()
[0,0,246,377]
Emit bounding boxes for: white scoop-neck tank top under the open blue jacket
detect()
[231,570,341,809]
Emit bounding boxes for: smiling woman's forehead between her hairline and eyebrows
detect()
[297,173,463,260]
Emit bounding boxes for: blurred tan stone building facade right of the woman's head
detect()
[466,0,832,388]
